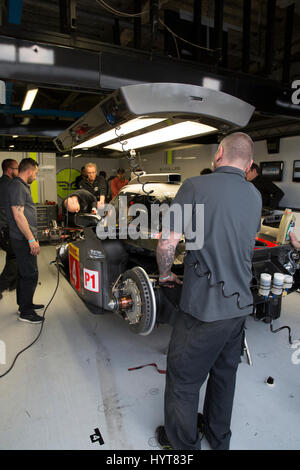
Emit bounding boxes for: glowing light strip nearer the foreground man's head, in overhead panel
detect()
[105,121,216,152]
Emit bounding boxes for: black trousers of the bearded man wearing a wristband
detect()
[11,238,39,315]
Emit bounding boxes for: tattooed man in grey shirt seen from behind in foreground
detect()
[157,133,261,450]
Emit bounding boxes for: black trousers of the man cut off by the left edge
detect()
[0,228,17,292]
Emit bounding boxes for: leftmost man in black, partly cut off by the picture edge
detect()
[0,158,19,299]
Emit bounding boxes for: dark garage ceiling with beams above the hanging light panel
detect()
[0,0,300,155]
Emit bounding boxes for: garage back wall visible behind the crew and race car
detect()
[0,137,300,210]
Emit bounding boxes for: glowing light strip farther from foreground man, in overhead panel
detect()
[74,118,166,149]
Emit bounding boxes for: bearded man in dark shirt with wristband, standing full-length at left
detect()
[6,158,44,323]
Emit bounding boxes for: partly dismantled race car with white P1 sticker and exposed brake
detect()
[57,174,300,335]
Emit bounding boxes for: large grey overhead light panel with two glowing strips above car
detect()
[54,83,254,152]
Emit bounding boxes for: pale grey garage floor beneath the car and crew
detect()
[0,245,300,450]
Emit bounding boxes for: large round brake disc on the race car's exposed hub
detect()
[122,266,156,336]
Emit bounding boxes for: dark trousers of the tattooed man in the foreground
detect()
[165,312,245,450]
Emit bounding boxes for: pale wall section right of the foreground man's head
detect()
[254,137,300,210]
